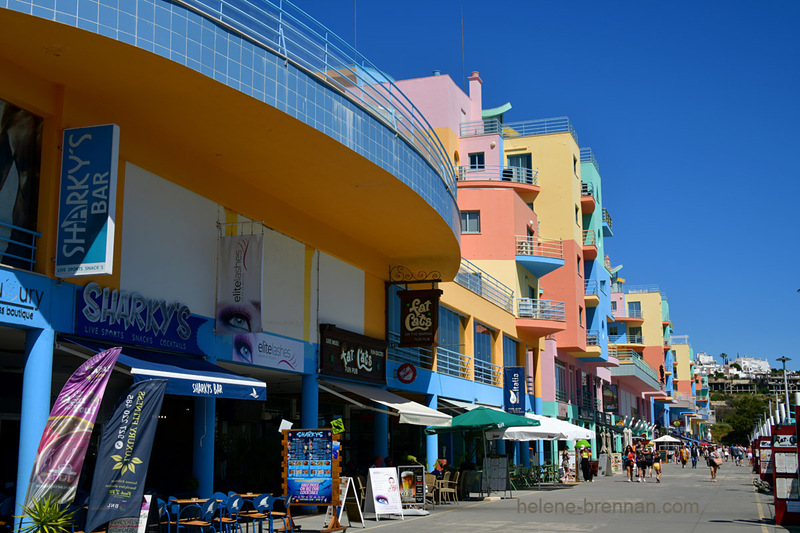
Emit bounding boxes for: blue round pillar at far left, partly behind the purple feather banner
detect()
[15,329,55,515]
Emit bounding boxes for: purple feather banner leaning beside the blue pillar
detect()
[25,348,122,505]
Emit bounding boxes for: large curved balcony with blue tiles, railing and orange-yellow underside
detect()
[0,0,460,279]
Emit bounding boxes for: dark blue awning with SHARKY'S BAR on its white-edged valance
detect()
[62,338,267,401]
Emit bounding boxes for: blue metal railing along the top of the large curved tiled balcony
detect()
[176,0,456,198]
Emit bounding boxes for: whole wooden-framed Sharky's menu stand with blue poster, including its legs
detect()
[283,428,346,533]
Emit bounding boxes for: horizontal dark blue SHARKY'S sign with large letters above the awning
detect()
[75,281,208,355]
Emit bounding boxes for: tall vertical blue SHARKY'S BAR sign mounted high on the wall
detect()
[56,124,119,278]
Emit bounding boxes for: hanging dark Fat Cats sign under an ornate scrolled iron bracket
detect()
[397,289,442,347]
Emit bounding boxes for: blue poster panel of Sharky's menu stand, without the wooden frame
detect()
[286,429,333,504]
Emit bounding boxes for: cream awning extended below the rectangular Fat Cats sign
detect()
[319,381,453,426]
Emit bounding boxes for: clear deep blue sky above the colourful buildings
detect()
[297,0,800,369]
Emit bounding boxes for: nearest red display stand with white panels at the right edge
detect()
[770,425,800,526]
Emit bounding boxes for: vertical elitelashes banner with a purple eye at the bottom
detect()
[216,234,264,335]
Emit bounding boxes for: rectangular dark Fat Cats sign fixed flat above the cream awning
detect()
[319,324,386,385]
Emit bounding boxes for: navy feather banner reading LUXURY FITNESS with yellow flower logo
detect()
[86,379,167,533]
